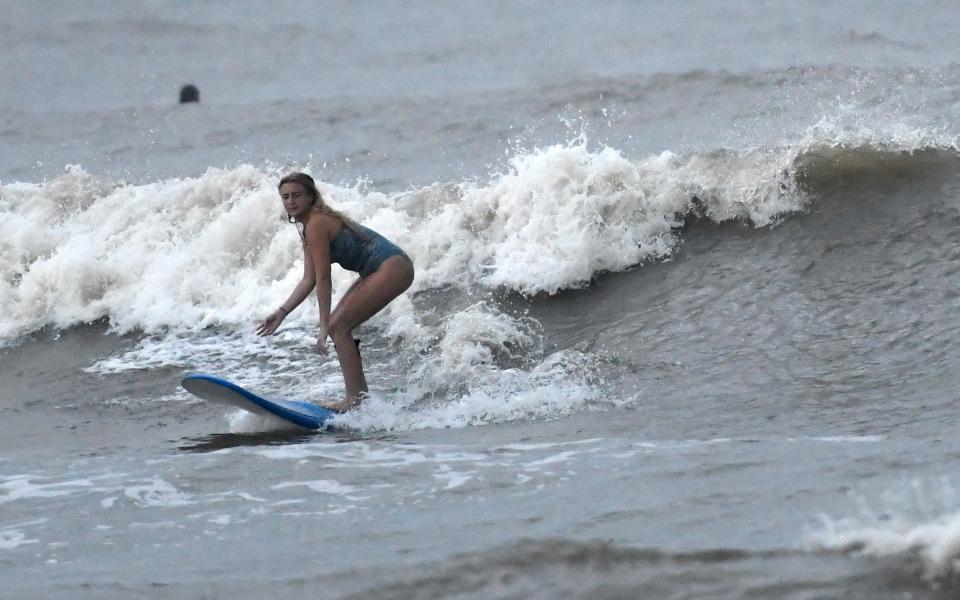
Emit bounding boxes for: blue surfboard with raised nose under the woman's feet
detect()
[180,373,337,429]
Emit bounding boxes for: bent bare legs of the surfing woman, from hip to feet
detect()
[329,256,413,410]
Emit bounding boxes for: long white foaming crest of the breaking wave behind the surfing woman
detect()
[0,120,957,341]
